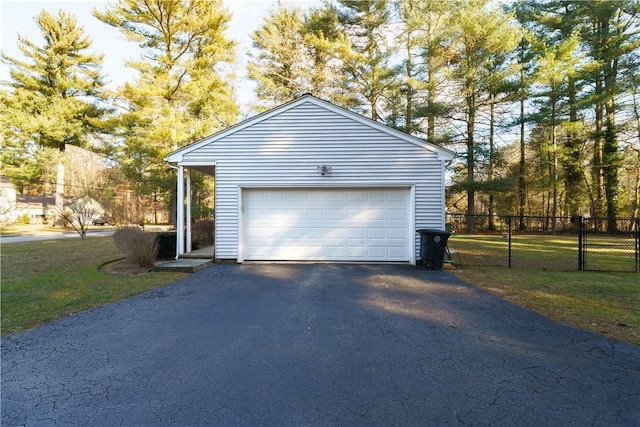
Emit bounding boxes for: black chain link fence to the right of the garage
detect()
[446,214,640,273]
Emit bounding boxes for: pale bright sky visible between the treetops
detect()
[0,0,321,111]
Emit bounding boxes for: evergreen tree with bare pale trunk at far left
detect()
[1,10,107,224]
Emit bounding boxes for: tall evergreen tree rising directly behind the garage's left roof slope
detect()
[94,0,238,203]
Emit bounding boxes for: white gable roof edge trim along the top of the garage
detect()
[164,94,455,163]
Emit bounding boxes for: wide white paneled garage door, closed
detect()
[243,188,410,261]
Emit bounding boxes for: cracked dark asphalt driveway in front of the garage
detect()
[2,264,640,426]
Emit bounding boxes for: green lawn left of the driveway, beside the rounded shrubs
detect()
[1,237,186,335]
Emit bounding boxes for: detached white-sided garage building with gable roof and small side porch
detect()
[166,95,454,264]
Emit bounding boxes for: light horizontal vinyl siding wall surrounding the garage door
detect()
[182,102,444,259]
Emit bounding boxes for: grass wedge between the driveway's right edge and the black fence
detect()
[453,266,640,345]
